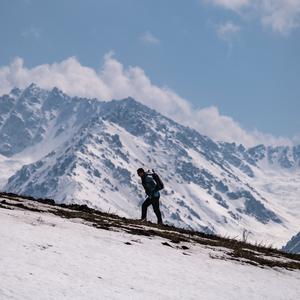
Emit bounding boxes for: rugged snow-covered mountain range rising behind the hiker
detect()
[0,84,300,243]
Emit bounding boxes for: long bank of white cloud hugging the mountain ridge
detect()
[0,53,290,146]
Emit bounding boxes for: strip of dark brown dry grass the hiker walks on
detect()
[0,193,300,270]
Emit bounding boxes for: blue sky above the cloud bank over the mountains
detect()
[0,0,300,143]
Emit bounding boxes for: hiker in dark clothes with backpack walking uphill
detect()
[137,168,163,224]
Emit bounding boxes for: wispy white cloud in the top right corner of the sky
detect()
[203,0,300,35]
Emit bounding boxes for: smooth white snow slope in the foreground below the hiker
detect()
[0,197,300,300]
